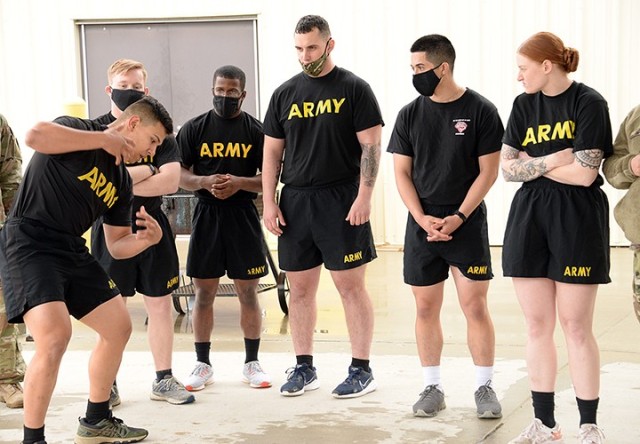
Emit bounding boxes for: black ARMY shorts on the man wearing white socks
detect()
[404,202,493,287]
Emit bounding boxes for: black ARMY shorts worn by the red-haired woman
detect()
[502,178,611,284]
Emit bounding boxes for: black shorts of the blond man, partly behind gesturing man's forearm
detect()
[91,208,180,296]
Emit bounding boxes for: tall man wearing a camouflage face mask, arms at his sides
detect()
[262,16,383,398]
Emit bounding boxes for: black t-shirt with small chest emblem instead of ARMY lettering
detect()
[387,89,504,205]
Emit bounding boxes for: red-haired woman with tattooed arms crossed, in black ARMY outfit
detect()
[501,32,613,444]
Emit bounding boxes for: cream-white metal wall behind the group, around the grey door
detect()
[0,0,640,244]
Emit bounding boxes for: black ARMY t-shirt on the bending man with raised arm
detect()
[11,116,133,236]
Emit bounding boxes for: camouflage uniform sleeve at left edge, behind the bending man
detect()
[0,114,22,227]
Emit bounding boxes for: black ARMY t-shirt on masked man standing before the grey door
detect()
[176,110,264,201]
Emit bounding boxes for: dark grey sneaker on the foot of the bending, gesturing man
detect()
[74,416,149,444]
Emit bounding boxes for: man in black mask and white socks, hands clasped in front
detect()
[388,34,504,418]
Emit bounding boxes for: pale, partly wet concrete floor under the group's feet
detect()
[0,248,640,444]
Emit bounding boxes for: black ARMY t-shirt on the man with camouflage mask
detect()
[264,66,384,187]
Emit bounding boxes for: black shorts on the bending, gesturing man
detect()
[0,218,120,323]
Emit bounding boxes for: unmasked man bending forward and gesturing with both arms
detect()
[0,97,173,444]
